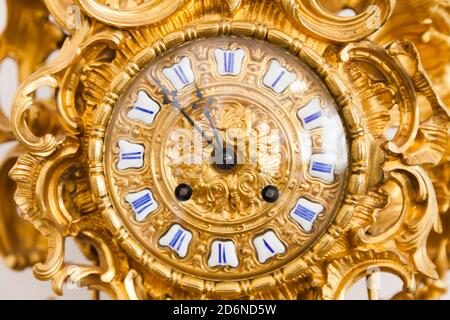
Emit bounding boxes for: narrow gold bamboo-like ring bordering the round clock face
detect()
[89,22,368,294]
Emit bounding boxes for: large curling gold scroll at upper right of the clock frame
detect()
[341,42,449,165]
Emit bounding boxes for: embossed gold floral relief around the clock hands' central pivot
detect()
[167,103,287,221]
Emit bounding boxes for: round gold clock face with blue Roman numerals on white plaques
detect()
[105,37,348,280]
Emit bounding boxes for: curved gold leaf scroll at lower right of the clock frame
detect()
[358,161,442,278]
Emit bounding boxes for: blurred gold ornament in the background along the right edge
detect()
[373,0,450,299]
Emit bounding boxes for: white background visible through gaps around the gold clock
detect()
[0,0,450,299]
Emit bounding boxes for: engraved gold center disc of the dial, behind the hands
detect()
[163,97,292,223]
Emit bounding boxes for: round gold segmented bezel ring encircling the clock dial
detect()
[88,22,374,296]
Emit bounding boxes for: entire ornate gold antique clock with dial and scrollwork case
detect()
[0,0,450,299]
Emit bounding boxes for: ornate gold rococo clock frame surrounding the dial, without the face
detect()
[0,0,449,299]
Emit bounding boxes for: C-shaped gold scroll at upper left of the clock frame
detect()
[11,15,120,156]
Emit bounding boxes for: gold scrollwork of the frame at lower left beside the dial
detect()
[11,140,143,299]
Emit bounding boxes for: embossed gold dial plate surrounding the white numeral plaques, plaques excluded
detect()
[103,37,348,289]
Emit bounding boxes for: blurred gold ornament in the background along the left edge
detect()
[0,0,62,270]
